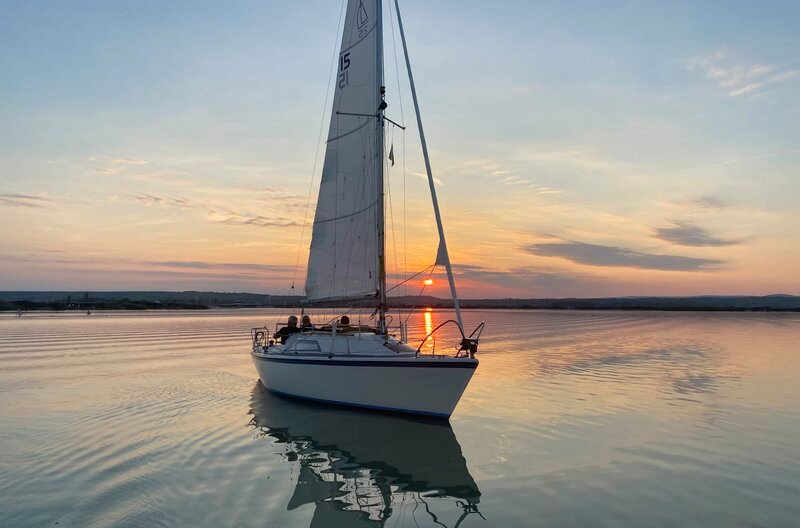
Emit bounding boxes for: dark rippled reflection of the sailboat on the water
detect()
[250,382,481,527]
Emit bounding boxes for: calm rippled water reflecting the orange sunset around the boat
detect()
[0,310,800,527]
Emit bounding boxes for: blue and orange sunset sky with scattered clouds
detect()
[0,0,800,298]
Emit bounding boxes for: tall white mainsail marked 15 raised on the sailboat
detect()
[306,0,383,301]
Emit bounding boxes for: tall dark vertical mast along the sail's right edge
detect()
[375,0,387,333]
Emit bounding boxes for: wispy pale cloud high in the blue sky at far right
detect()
[686,50,800,98]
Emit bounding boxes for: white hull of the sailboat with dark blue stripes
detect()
[252,347,478,418]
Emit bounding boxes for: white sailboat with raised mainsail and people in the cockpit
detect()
[251,0,484,418]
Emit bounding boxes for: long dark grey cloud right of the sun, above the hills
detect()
[523,241,723,271]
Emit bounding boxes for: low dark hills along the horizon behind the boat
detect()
[0,291,800,311]
